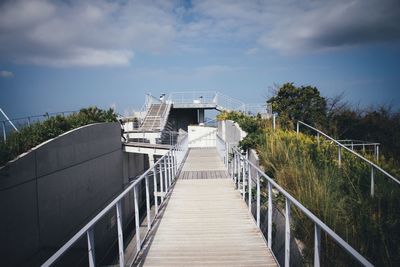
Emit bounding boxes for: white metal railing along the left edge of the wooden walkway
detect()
[42,136,188,267]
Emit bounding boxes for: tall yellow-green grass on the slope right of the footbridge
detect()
[257,127,400,266]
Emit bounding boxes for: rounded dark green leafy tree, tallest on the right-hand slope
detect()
[267,83,327,126]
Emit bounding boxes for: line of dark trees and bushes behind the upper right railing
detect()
[267,83,400,164]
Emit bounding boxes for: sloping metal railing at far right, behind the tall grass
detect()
[296,121,400,196]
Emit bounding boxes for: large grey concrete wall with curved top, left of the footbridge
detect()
[0,123,146,266]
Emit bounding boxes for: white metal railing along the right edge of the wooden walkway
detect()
[223,144,373,267]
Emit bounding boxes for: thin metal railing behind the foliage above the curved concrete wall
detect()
[0,110,79,142]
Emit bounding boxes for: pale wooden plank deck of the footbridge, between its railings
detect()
[136,149,277,266]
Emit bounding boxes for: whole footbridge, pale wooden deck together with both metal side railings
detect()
[42,131,372,267]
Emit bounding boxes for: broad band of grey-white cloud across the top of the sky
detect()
[0,0,400,67]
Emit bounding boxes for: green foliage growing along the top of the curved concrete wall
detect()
[0,107,117,166]
